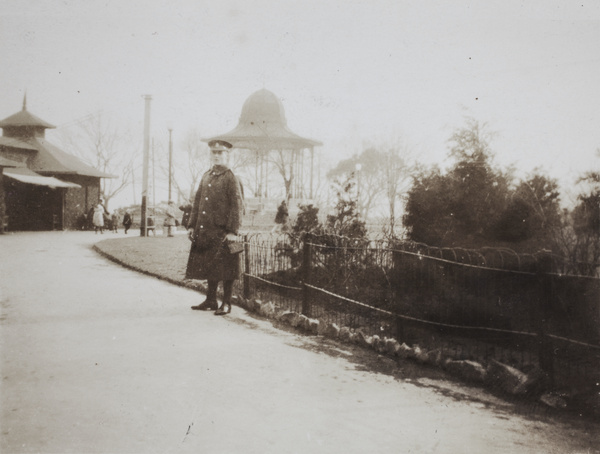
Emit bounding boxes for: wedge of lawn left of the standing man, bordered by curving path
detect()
[94,235,204,290]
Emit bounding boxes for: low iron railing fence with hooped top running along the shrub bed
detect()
[243,233,600,392]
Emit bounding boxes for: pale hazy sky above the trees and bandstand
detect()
[0,0,600,207]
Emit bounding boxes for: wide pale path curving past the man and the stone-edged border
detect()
[0,232,599,454]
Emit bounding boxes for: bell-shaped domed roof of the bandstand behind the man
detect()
[203,88,322,150]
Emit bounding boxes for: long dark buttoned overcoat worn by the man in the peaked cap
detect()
[186,166,243,280]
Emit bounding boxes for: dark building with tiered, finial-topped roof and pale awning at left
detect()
[0,98,114,231]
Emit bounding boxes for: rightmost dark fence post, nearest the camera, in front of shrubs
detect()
[535,251,554,386]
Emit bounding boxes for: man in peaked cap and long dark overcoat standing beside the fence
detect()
[185,140,243,315]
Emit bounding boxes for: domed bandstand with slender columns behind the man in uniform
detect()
[203,89,322,199]
